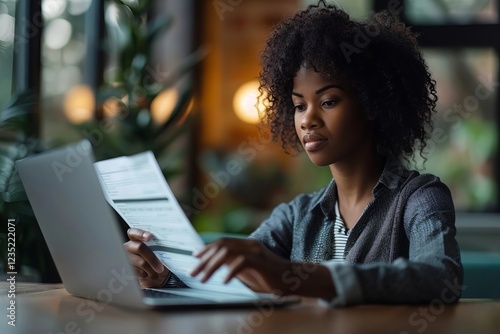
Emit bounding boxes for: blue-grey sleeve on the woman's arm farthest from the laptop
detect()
[324,178,465,306]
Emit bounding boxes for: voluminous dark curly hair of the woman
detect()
[259,0,437,161]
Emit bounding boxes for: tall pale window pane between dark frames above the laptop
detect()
[40,0,91,146]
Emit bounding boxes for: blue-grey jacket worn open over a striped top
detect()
[250,158,463,306]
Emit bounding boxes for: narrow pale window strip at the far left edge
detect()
[0,0,16,106]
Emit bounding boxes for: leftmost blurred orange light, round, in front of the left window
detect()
[64,85,95,124]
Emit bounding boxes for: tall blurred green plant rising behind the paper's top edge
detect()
[72,0,205,176]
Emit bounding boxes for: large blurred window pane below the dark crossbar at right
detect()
[424,49,499,211]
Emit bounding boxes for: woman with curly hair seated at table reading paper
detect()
[125,1,463,305]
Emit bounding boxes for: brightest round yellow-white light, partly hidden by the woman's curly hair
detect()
[233,80,264,124]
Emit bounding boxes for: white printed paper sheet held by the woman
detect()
[94,151,255,295]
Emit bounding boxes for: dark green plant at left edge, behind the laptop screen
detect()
[0,92,60,282]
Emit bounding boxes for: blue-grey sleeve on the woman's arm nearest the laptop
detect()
[248,203,294,259]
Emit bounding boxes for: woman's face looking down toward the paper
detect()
[292,66,372,166]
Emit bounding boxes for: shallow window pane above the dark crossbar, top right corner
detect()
[405,0,499,24]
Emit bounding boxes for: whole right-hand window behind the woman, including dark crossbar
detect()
[403,0,500,212]
